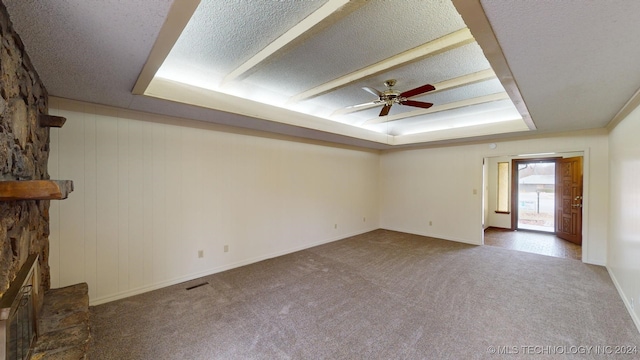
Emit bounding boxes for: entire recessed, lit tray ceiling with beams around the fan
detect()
[147,0,518,146]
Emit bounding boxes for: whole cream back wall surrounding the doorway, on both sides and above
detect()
[380,130,609,265]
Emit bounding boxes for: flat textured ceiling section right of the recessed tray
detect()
[482,0,640,131]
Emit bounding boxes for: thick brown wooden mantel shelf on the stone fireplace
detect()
[0,180,73,201]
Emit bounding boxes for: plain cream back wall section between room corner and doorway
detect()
[380,146,483,244]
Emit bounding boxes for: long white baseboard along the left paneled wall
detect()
[89,227,378,306]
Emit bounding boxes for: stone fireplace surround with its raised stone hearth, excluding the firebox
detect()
[0,0,90,359]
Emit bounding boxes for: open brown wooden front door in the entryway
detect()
[555,156,582,245]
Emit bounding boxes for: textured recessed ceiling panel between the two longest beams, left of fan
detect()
[246,0,465,95]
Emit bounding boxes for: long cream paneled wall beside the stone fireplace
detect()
[49,98,379,304]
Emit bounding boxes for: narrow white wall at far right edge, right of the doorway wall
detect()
[607,102,640,329]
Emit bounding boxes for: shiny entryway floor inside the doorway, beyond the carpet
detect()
[484,227,582,260]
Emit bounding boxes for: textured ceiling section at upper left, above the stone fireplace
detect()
[2,0,173,108]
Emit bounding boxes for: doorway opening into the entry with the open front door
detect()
[483,152,583,260]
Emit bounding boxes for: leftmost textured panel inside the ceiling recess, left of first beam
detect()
[157,0,325,87]
